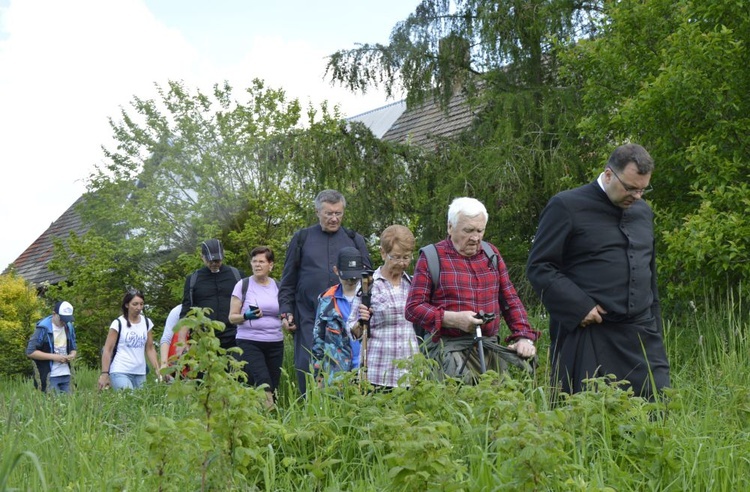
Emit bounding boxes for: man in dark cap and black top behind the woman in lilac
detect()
[180,239,243,349]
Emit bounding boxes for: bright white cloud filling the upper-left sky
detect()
[0,0,400,270]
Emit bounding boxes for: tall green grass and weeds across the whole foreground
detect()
[0,301,750,492]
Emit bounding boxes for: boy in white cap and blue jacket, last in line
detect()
[26,301,77,393]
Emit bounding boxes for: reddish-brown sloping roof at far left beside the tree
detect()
[11,196,88,287]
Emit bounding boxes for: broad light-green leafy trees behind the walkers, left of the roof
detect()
[50,80,428,338]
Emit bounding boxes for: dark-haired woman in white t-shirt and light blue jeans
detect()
[99,290,161,390]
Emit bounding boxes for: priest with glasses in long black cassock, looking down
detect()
[526,144,669,398]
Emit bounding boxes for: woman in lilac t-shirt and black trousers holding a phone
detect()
[229,246,288,408]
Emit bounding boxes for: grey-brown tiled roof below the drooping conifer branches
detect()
[383,93,477,150]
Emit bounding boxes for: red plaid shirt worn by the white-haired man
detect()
[406,236,540,342]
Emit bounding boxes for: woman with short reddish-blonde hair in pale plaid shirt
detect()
[347,225,419,388]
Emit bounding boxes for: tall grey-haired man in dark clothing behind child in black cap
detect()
[279,190,372,395]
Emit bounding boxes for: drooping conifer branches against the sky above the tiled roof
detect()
[327,0,599,106]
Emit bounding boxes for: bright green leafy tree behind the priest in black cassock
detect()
[566,0,750,298]
